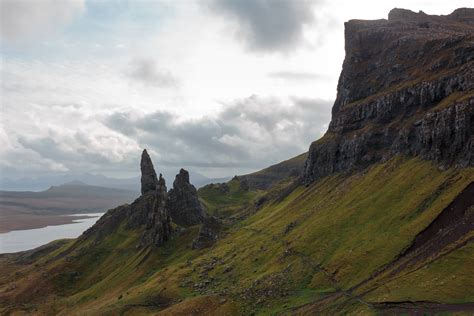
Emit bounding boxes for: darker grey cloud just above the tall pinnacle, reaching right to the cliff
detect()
[105,96,331,169]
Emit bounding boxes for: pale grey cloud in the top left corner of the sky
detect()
[0,0,85,42]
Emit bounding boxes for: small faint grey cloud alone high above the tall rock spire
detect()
[125,59,178,87]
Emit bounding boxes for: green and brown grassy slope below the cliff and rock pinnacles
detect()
[0,158,474,315]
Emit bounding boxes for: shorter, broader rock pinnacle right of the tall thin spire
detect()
[167,169,204,226]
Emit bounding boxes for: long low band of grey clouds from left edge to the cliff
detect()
[7,95,332,179]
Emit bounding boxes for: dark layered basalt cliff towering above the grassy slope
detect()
[304,9,474,184]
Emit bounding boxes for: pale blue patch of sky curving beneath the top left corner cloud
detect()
[0,0,175,60]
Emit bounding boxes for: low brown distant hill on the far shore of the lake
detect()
[0,181,139,215]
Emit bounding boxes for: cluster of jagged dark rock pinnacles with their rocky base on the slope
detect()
[79,150,207,247]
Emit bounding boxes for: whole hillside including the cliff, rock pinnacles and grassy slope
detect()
[0,9,474,315]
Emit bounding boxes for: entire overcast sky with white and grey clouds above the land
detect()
[0,0,472,183]
